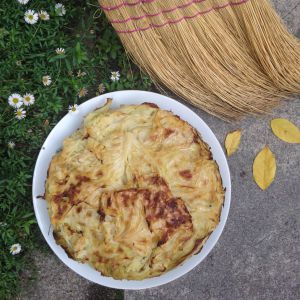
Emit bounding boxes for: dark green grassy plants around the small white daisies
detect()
[0,0,151,299]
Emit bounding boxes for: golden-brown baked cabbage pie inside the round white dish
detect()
[45,99,224,280]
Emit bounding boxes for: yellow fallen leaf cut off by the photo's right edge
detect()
[271,119,300,144]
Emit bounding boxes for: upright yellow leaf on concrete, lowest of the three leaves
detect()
[253,146,276,190]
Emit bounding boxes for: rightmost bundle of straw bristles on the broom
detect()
[236,0,300,93]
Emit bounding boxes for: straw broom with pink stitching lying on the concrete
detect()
[99,0,300,119]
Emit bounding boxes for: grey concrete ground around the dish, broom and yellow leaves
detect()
[19,0,300,300]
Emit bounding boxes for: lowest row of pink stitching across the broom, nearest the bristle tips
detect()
[111,0,249,33]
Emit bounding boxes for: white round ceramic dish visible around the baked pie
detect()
[32,91,231,289]
